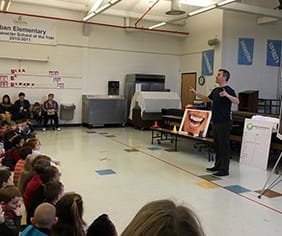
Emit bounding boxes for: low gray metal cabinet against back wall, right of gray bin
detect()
[82,95,126,127]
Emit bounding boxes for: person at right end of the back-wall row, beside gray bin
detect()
[43,93,60,131]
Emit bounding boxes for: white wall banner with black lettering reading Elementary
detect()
[0,14,56,45]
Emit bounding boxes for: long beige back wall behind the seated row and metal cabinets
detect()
[0,3,183,123]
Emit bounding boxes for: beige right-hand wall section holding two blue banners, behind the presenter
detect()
[222,11,282,98]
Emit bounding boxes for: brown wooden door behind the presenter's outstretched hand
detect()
[181,72,197,108]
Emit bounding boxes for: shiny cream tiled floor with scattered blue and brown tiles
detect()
[38,127,282,236]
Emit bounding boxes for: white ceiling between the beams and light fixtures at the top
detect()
[7,0,279,21]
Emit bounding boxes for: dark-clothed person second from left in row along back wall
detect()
[13,92,30,120]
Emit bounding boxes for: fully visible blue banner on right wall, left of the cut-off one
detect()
[238,38,255,65]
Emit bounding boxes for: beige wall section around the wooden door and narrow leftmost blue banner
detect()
[181,10,223,94]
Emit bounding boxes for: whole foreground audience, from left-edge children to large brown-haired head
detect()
[0,121,204,236]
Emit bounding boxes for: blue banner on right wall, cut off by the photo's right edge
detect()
[266,40,281,66]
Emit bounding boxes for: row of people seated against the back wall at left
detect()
[0,92,60,131]
